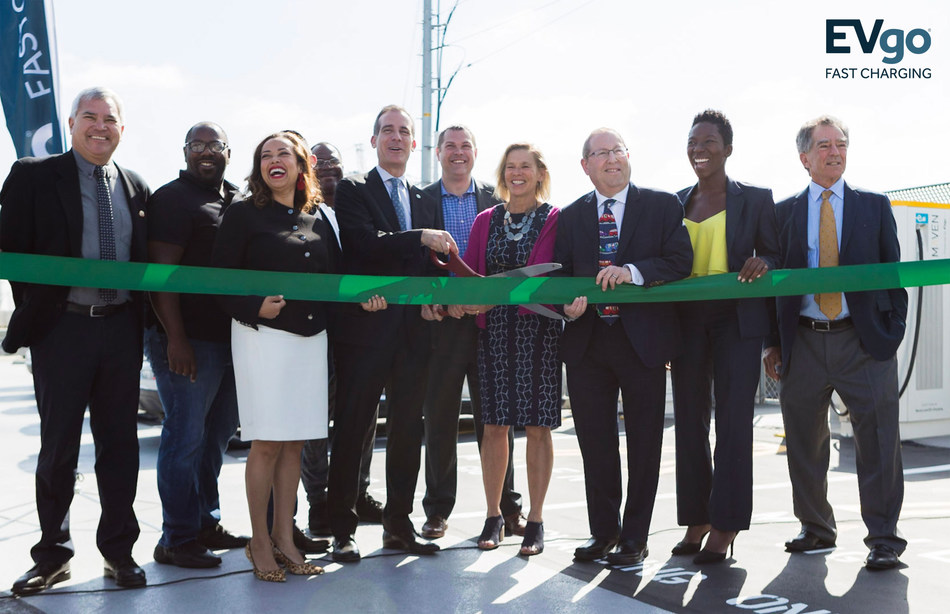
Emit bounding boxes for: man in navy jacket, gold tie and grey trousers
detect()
[764,116,907,570]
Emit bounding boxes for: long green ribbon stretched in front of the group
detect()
[0,252,950,305]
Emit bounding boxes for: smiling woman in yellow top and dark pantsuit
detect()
[672,110,778,564]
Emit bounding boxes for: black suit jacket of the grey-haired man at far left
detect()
[0,150,151,352]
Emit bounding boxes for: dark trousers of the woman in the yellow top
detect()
[671,301,762,531]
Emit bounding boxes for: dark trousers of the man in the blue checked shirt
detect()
[422,317,521,518]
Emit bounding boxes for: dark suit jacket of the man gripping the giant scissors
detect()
[334,168,440,345]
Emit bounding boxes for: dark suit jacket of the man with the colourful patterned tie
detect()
[552,184,693,367]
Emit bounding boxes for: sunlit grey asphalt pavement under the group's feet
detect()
[0,355,950,614]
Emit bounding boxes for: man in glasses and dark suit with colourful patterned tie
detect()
[554,128,693,565]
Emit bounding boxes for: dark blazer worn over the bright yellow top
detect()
[676,179,779,337]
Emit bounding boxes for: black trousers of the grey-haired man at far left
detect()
[30,307,142,563]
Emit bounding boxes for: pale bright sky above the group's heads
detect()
[0,0,950,205]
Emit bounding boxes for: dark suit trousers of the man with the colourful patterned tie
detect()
[567,318,666,543]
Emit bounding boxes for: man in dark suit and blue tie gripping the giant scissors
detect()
[327,105,458,562]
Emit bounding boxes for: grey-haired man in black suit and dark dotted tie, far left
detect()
[0,88,149,595]
